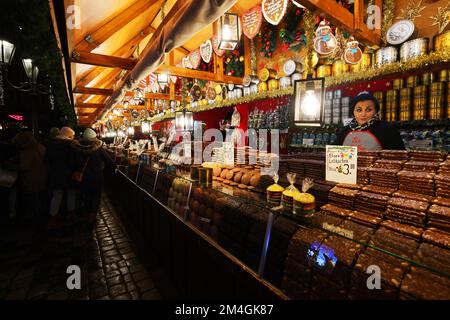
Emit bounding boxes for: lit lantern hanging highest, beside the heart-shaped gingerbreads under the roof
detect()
[217,12,241,50]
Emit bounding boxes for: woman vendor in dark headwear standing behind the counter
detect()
[336,91,405,151]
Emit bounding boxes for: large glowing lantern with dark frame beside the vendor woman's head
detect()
[291,74,325,127]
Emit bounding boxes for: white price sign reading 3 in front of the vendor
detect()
[325,146,358,184]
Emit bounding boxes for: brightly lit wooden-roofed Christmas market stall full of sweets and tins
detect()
[60,0,450,299]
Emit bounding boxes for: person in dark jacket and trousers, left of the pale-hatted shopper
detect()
[46,127,76,229]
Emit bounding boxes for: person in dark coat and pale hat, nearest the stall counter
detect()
[74,128,115,223]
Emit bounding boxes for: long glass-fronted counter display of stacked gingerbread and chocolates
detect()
[117,141,450,299]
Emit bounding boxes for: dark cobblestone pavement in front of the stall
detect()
[0,196,161,300]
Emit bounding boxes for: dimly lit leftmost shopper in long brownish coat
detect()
[13,132,47,216]
